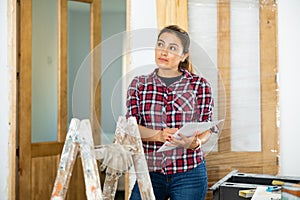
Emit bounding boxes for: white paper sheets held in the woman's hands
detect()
[157,119,224,152]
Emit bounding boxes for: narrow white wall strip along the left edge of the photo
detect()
[0,1,12,200]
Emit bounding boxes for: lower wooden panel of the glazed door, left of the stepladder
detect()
[31,155,59,200]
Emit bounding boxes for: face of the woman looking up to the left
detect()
[155,32,188,71]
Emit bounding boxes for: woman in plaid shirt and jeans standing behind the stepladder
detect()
[127,25,213,200]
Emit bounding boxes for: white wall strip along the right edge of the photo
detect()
[278,0,300,176]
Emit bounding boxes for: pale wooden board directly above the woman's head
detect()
[156,0,188,30]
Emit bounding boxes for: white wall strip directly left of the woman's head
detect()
[126,0,158,79]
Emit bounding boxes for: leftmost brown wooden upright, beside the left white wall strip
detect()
[18,0,32,199]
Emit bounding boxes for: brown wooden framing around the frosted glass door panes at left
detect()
[16,0,101,199]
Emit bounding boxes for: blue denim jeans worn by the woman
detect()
[130,161,207,200]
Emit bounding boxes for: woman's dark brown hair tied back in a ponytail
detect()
[158,25,193,72]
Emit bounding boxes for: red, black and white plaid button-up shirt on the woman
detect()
[127,69,214,174]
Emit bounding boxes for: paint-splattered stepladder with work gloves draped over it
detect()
[51,116,155,200]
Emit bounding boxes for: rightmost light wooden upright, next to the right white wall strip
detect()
[260,0,279,174]
